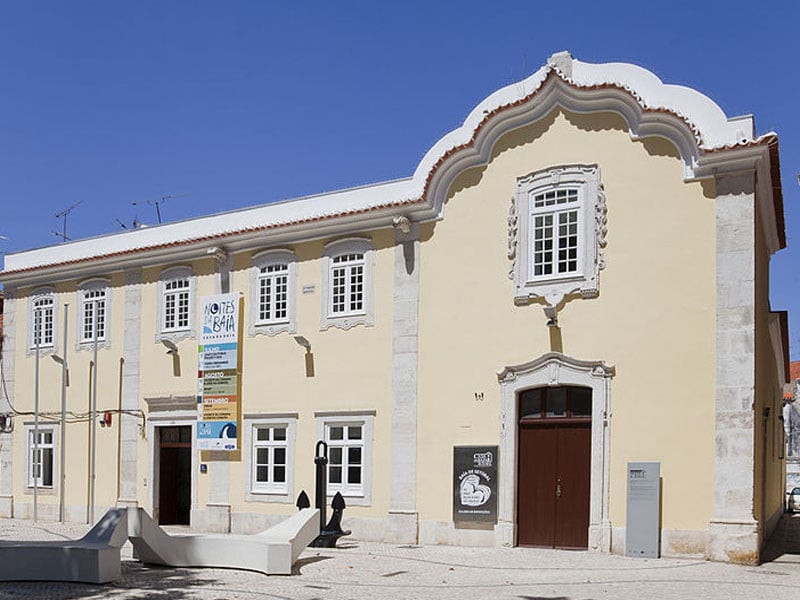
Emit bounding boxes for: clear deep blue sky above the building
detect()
[0,0,800,360]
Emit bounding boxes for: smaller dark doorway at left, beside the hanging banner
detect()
[158,426,192,525]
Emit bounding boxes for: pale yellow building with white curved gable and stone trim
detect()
[0,53,788,563]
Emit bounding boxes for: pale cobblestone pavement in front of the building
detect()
[0,515,800,600]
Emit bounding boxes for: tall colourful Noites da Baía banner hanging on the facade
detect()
[197,294,242,452]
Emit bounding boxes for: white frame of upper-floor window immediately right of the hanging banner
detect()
[249,249,297,336]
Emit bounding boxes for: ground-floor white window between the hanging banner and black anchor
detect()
[244,414,297,503]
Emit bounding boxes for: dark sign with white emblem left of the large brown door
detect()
[453,446,497,523]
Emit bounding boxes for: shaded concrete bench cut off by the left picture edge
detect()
[0,508,128,583]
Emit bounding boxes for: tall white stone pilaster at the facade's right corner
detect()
[706,171,759,564]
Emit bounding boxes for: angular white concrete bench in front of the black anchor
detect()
[128,508,319,575]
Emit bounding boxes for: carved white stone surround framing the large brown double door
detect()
[495,352,615,552]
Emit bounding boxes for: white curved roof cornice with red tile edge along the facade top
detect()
[0,52,774,286]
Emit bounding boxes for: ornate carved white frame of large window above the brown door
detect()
[508,165,606,306]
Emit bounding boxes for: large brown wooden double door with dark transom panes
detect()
[517,388,592,548]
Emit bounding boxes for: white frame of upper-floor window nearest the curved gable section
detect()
[321,238,375,331]
